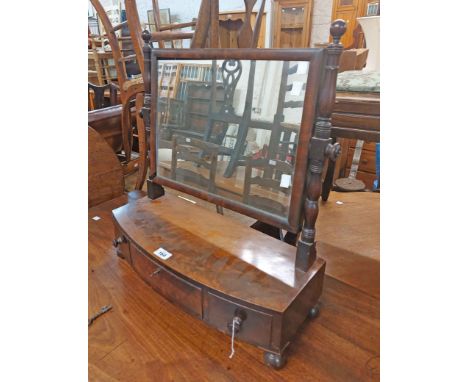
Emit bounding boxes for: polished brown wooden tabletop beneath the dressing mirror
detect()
[88,193,380,382]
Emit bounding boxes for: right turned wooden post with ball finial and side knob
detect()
[296,20,346,271]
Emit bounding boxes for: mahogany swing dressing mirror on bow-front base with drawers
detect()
[113,20,345,368]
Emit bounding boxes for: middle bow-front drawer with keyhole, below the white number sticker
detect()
[130,245,202,318]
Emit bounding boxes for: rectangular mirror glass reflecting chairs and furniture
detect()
[157,60,308,217]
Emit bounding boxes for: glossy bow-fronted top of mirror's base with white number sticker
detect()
[113,194,325,312]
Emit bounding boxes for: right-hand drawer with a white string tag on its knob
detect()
[203,291,273,348]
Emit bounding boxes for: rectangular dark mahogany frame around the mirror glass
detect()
[145,48,326,233]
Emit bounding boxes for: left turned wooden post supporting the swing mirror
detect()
[140,30,164,199]
